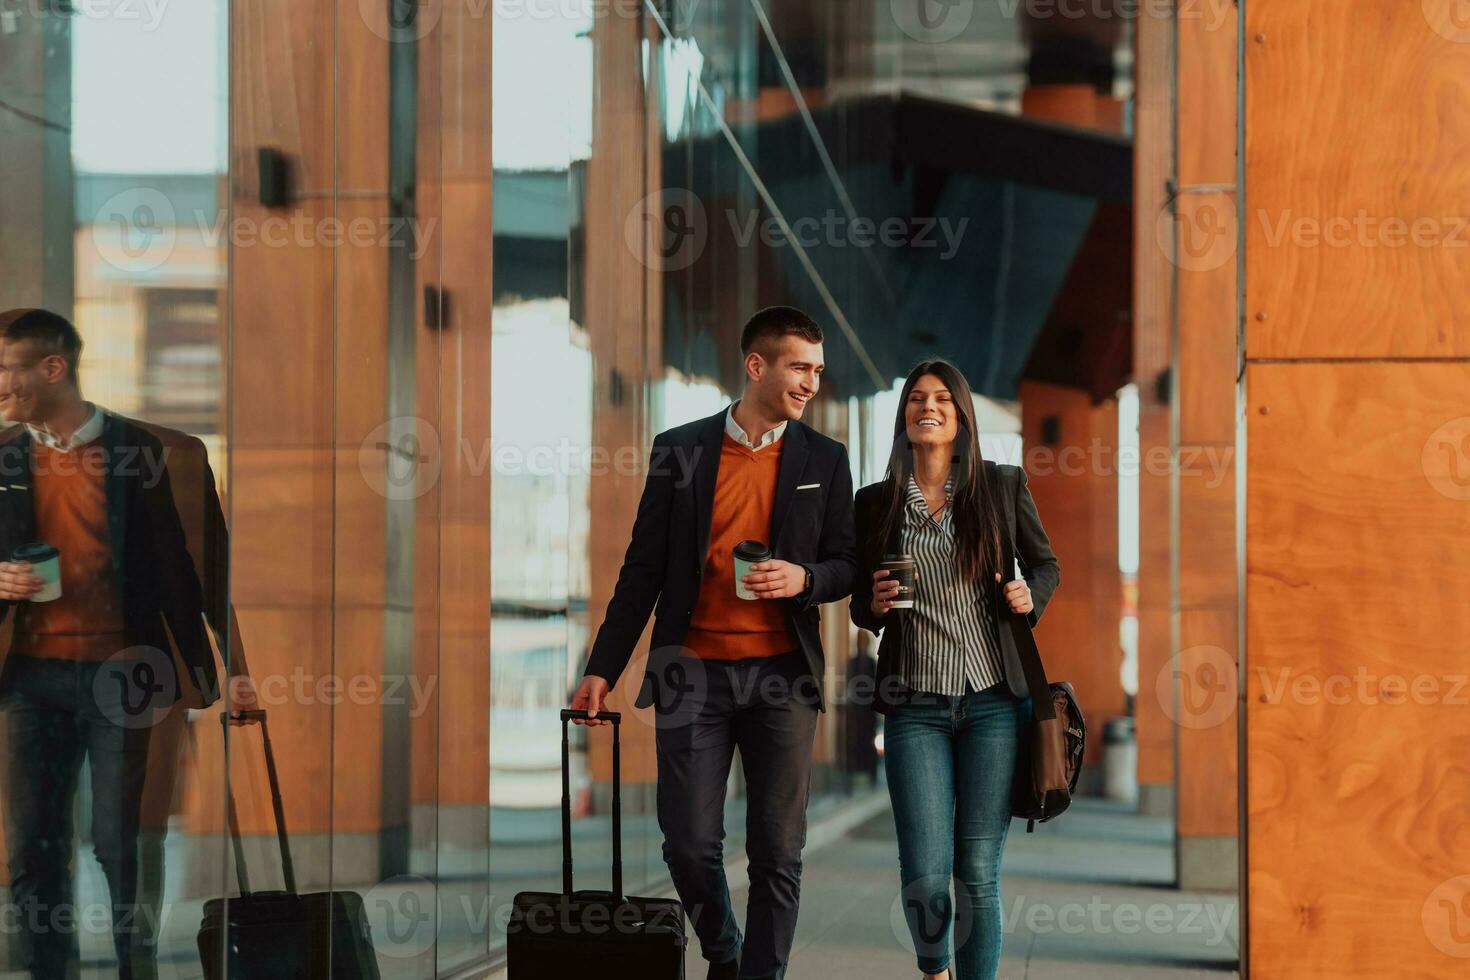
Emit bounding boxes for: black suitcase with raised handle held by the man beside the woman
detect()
[506,710,689,980]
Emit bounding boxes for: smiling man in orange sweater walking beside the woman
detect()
[572,307,857,980]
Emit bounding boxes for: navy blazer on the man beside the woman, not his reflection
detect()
[587,410,857,708]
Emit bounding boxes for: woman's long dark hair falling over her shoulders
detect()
[875,360,1003,582]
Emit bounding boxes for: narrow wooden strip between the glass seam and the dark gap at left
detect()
[327,3,393,884]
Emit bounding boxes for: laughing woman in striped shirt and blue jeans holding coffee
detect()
[851,360,1061,980]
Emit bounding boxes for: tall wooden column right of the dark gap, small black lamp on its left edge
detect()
[413,0,492,871]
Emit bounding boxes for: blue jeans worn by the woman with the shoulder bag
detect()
[883,683,1025,980]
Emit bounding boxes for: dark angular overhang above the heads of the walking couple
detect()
[663,94,1132,400]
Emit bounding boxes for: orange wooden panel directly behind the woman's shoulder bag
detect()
[1020,381,1127,792]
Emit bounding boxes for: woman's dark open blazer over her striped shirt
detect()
[851,460,1061,714]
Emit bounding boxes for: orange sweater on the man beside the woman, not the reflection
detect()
[684,435,797,660]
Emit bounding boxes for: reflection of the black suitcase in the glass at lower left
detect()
[198,711,379,980]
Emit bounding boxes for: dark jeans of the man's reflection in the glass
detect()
[0,654,153,980]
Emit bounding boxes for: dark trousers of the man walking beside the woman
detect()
[654,652,817,980]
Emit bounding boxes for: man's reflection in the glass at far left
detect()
[0,310,219,980]
